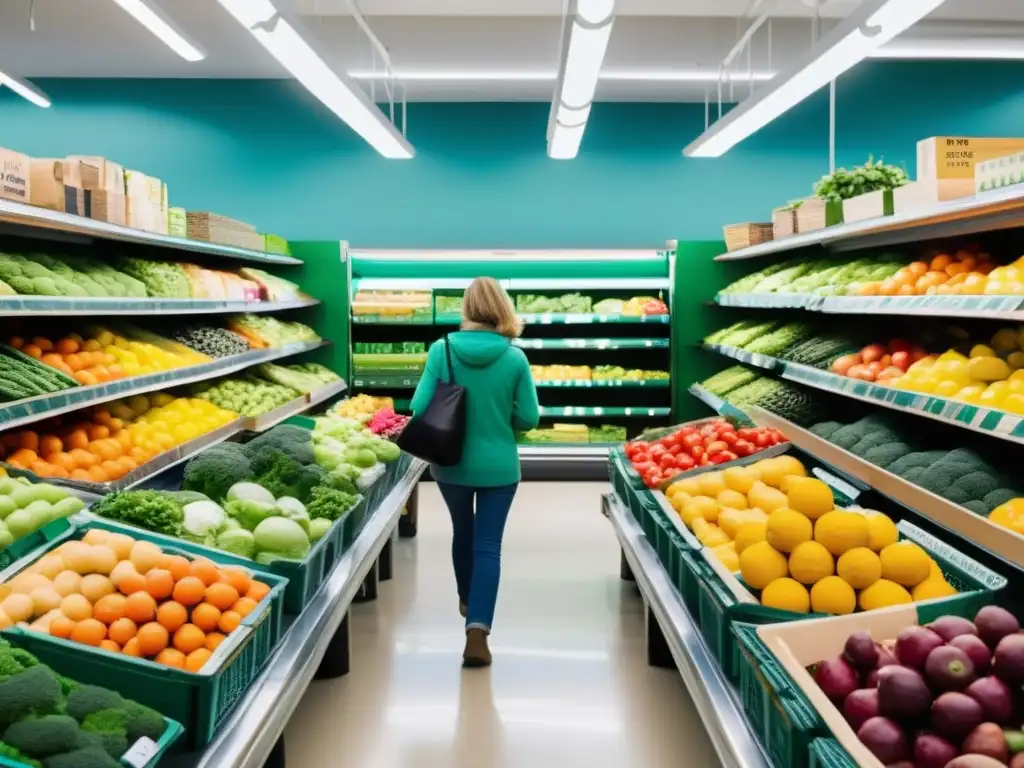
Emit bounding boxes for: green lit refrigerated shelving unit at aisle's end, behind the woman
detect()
[348,251,676,479]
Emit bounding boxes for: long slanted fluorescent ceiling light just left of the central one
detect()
[219,0,415,160]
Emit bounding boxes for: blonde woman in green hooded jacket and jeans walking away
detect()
[412,278,540,667]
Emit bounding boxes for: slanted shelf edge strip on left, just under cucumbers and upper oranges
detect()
[0,341,330,436]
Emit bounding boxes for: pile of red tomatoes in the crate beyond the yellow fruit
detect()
[626,419,786,488]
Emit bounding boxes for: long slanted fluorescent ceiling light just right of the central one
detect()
[683,0,944,158]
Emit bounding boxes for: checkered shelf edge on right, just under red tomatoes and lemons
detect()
[705,344,1024,443]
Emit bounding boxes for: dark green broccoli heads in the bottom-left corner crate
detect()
[0,639,174,768]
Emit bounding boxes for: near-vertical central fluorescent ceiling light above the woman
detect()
[548,0,615,160]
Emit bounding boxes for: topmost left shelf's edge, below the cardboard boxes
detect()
[0,200,302,264]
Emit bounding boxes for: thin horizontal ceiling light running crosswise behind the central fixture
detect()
[348,70,774,83]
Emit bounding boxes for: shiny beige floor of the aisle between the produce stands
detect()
[286,483,718,768]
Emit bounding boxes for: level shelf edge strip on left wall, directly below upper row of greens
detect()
[0,296,319,317]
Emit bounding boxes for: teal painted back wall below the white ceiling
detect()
[0,62,1024,248]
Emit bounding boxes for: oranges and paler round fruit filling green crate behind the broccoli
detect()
[0,528,270,671]
